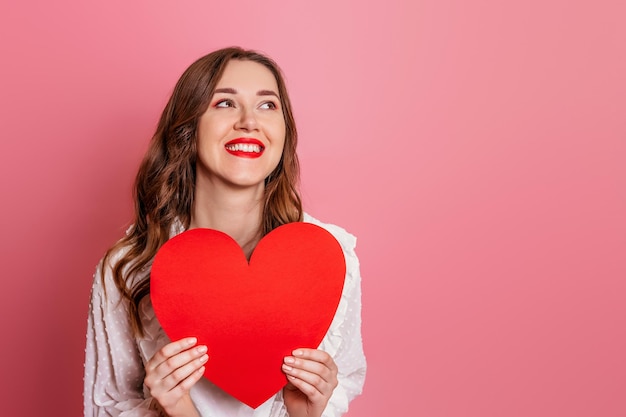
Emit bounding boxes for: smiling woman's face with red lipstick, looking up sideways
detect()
[196,60,285,188]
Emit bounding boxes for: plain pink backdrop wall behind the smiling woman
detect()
[0,0,626,417]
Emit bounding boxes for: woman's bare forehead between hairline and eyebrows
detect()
[216,59,278,94]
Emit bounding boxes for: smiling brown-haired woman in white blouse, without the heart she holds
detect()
[84,48,365,417]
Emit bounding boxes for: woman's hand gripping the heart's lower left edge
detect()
[144,337,209,417]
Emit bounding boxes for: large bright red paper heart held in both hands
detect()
[150,222,346,408]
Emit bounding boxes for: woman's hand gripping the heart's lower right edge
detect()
[283,349,338,417]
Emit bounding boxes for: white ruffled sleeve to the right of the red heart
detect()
[305,216,366,417]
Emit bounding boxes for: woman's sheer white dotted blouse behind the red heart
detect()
[83,214,366,417]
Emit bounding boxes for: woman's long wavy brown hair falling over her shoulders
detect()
[102,47,302,336]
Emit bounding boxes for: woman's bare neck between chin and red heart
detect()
[189,180,264,259]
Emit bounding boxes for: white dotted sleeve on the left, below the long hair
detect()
[83,255,158,417]
